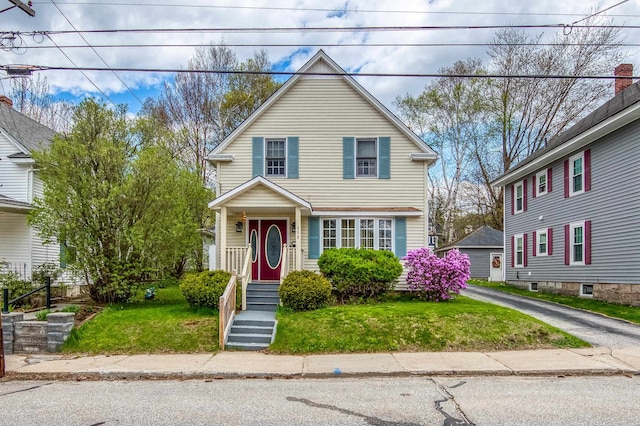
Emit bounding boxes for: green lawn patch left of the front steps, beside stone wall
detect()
[63,286,218,354]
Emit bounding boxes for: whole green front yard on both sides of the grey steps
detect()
[63,286,587,354]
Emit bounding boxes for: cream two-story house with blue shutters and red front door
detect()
[209,51,437,287]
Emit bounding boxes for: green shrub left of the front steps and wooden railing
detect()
[180,269,231,309]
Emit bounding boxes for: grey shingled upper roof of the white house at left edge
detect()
[0,102,56,158]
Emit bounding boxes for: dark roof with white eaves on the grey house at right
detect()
[492,82,640,186]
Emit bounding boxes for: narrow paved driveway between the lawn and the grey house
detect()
[462,285,640,349]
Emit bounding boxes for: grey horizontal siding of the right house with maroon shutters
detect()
[505,121,640,291]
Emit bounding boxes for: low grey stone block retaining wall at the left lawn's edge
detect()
[2,312,75,354]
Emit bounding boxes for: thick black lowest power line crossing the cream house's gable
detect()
[6,65,640,80]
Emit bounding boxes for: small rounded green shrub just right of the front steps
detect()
[279,271,331,311]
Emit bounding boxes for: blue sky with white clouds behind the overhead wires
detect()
[0,0,640,110]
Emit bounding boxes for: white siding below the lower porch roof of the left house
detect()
[0,212,31,273]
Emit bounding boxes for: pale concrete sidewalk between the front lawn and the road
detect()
[3,347,640,380]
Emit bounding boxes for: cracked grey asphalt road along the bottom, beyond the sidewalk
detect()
[0,376,640,426]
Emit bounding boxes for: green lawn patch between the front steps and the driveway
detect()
[269,296,589,354]
